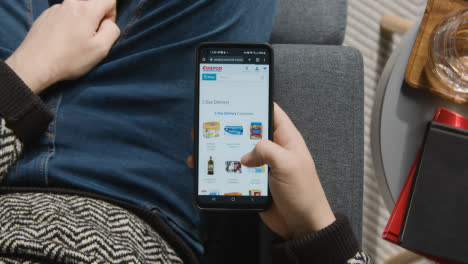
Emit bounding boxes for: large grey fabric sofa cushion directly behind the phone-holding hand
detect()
[273,45,364,241]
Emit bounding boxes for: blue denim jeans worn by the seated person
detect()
[0,0,276,254]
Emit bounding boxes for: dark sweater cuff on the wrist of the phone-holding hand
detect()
[273,214,371,264]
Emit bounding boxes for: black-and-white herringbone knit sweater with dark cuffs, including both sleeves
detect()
[0,58,371,264]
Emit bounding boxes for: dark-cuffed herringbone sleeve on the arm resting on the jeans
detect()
[0,60,53,182]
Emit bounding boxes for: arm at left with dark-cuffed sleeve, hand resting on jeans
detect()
[0,0,120,182]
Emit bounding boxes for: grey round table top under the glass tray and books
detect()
[371,21,468,210]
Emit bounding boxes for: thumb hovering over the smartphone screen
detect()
[241,139,287,169]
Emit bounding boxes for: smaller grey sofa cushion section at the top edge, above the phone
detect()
[270,0,347,45]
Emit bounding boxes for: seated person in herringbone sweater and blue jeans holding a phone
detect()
[0,0,370,263]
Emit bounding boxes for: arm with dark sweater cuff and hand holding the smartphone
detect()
[242,104,371,264]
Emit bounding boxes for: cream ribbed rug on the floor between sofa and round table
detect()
[344,0,427,263]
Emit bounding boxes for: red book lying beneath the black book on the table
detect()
[382,108,468,264]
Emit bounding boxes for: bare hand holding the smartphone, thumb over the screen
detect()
[241,104,336,239]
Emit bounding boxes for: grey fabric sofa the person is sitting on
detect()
[206,0,364,263]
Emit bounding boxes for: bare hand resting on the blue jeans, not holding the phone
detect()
[6,0,120,94]
